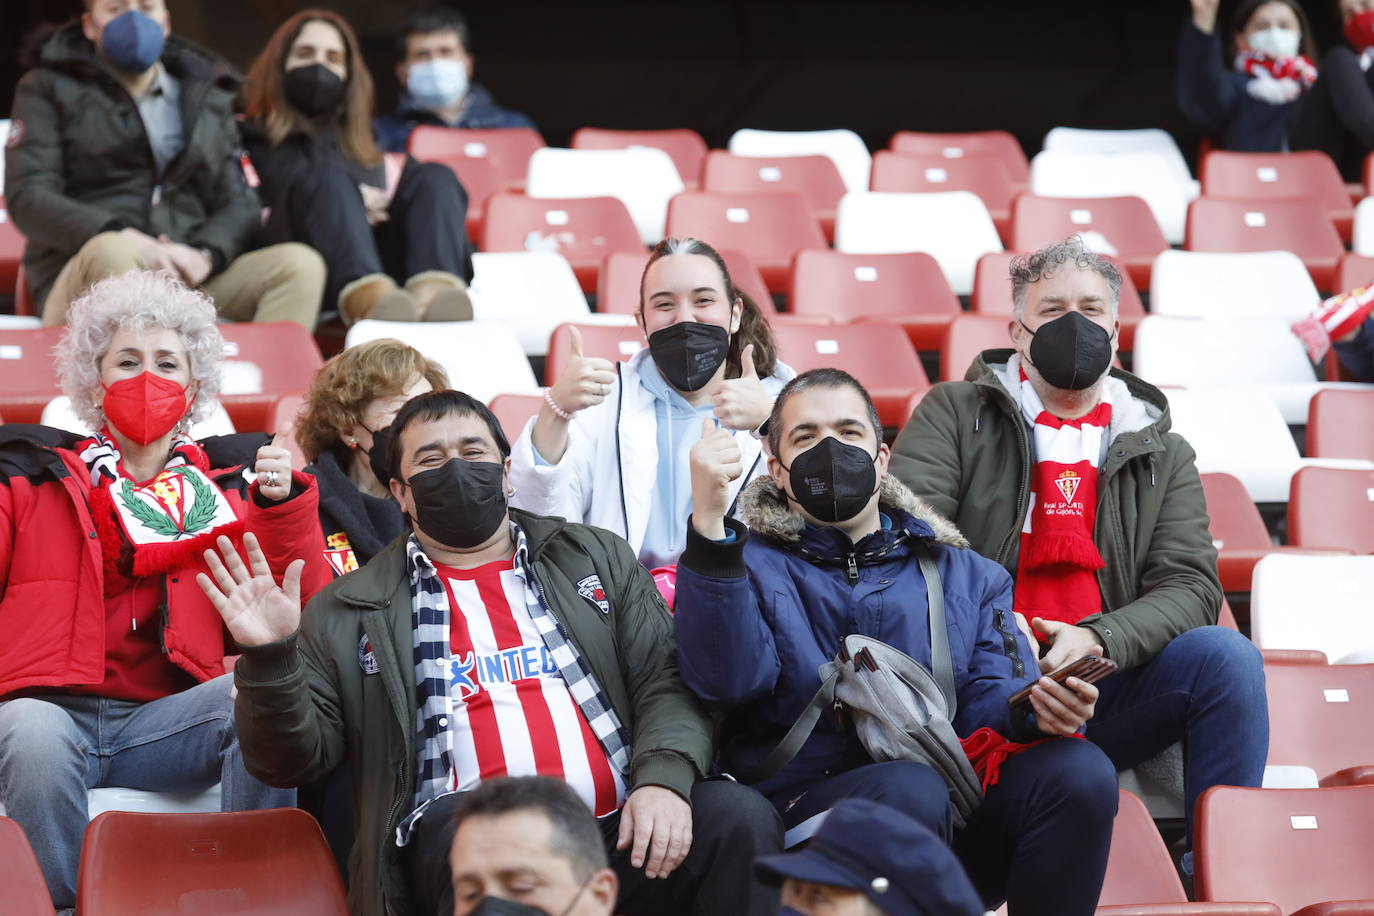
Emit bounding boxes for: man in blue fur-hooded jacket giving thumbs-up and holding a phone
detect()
[675,369,1117,916]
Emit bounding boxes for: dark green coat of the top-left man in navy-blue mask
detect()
[5,23,260,305]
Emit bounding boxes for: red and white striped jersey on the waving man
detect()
[434,560,625,817]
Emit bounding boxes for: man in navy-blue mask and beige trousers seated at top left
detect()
[4,0,324,330]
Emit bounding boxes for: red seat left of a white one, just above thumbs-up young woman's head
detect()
[668,191,826,290]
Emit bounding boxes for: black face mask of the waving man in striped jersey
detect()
[408,457,506,551]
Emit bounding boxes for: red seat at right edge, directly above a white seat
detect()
[1289,469,1374,554]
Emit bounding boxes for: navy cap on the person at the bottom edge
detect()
[754,798,985,916]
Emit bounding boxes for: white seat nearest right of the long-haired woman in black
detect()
[525,147,683,244]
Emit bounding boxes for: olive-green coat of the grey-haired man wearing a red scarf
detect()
[890,350,1221,667]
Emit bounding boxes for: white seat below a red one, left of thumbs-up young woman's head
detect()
[469,251,591,357]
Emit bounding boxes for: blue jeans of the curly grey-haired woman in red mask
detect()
[0,674,295,909]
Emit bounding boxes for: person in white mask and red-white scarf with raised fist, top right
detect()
[1175,0,1316,152]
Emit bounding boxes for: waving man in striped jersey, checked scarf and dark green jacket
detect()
[201,391,782,916]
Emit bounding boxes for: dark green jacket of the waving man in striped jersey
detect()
[234,509,713,916]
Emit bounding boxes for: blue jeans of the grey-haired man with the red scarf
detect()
[1087,626,1270,849]
